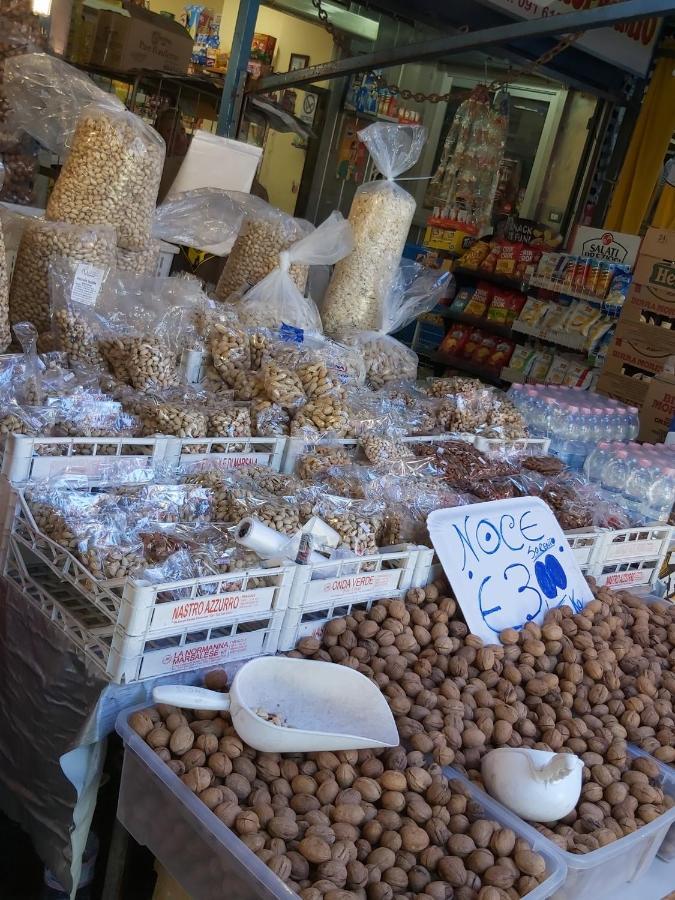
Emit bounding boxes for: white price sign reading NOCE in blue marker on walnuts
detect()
[427,497,593,644]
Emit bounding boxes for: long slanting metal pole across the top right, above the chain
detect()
[250,0,675,93]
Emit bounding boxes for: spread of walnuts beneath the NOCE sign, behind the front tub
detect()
[291,584,675,853]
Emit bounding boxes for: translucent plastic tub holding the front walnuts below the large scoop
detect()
[116,710,565,900]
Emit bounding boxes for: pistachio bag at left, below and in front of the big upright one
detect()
[9,219,115,334]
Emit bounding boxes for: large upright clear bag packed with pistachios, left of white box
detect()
[46,104,166,250]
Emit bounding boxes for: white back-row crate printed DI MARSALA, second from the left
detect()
[167,437,287,472]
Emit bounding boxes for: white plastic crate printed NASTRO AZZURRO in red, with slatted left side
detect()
[3,482,296,640]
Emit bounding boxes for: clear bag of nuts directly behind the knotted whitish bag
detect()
[215,193,314,300]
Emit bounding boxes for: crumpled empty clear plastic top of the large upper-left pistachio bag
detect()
[3,53,124,156]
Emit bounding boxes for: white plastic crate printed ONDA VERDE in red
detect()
[288,545,426,609]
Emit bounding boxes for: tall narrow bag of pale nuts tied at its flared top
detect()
[322,122,427,335]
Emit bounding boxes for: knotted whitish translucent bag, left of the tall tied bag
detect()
[236,212,354,332]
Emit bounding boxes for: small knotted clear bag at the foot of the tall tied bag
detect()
[340,259,452,390]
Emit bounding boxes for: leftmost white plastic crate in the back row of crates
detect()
[0,434,170,485]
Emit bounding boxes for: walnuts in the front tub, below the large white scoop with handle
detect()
[129,671,547,900]
